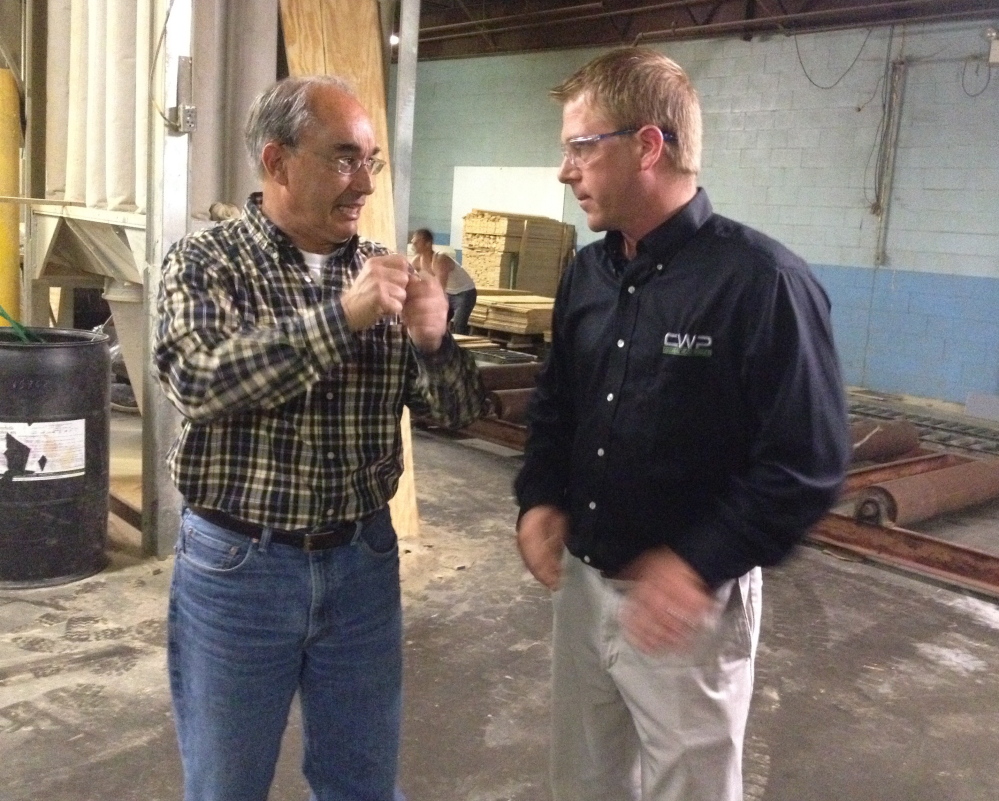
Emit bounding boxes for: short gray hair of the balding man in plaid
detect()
[245,75,357,177]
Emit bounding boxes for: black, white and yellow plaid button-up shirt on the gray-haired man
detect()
[153,195,485,529]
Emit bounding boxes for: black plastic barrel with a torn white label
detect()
[0,328,111,588]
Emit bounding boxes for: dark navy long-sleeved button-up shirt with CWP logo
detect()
[515,190,850,587]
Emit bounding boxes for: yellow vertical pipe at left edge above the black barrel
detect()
[0,69,21,325]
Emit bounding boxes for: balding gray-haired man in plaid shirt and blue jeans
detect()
[154,76,484,801]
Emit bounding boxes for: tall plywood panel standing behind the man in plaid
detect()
[281,0,419,536]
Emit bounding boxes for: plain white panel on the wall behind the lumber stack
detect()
[451,167,565,248]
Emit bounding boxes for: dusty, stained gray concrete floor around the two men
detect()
[0,424,999,801]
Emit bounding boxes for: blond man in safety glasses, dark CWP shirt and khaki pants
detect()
[515,48,850,801]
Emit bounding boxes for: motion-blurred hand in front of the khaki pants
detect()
[620,548,717,653]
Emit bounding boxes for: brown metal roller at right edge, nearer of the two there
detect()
[854,459,999,527]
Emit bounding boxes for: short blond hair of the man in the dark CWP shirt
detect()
[550,47,701,175]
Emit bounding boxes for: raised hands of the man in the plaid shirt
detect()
[340,254,447,353]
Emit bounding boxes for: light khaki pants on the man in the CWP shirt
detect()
[552,555,762,801]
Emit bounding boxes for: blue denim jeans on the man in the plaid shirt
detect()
[168,509,402,801]
